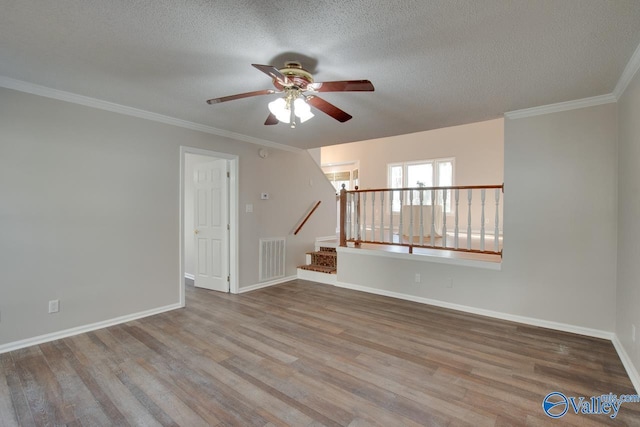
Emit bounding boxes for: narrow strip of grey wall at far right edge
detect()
[616,69,640,378]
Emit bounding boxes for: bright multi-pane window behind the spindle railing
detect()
[388,158,455,212]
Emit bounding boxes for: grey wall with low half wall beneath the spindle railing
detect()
[340,104,617,332]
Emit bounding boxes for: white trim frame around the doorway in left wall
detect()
[178,146,240,307]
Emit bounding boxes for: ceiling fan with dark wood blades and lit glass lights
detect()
[207,61,374,128]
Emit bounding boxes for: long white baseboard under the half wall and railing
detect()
[336,282,615,340]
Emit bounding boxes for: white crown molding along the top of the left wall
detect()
[0,76,305,153]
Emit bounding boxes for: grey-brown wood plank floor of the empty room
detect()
[0,280,640,427]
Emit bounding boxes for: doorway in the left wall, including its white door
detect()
[179,147,239,306]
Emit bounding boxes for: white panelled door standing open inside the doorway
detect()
[193,160,229,292]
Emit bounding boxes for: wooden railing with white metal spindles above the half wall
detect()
[339,184,504,255]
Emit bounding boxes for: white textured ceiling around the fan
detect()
[0,0,640,148]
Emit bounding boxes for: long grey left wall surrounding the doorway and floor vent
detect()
[0,89,335,350]
